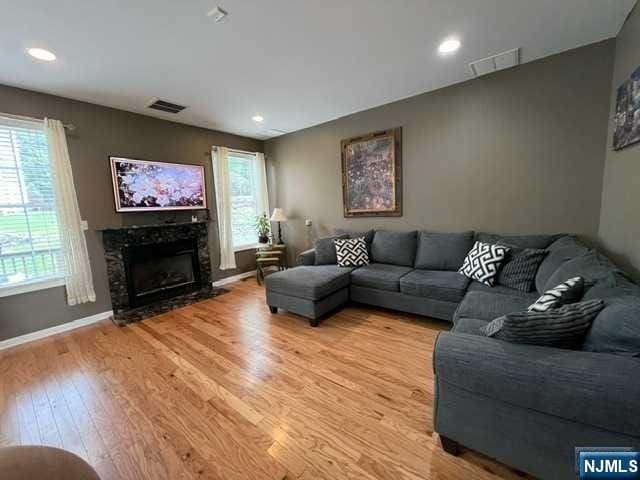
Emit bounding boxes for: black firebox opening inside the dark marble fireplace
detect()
[124,238,201,307]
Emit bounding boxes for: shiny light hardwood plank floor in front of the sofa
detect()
[0,280,522,480]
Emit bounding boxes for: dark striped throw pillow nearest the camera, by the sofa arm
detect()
[480,300,604,349]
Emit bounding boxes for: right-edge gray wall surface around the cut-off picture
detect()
[599,7,640,277]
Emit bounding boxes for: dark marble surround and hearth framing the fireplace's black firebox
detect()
[102,221,224,325]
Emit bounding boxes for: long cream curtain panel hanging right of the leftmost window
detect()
[44,118,96,305]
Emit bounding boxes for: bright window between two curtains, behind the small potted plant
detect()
[228,150,268,250]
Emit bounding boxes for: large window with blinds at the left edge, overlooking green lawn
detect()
[0,118,63,291]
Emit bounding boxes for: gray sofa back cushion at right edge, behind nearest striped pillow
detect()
[582,297,640,357]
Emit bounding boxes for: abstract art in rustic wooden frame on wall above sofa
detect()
[341,127,402,217]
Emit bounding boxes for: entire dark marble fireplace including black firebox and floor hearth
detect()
[102,222,224,325]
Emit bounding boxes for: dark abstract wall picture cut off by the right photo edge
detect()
[613,67,640,150]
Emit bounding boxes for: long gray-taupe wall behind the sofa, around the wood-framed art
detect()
[266,40,615,262]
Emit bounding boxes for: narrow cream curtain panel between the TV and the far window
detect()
[211,147,236,270]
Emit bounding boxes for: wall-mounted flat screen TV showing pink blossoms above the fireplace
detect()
[109,157,207,212]
